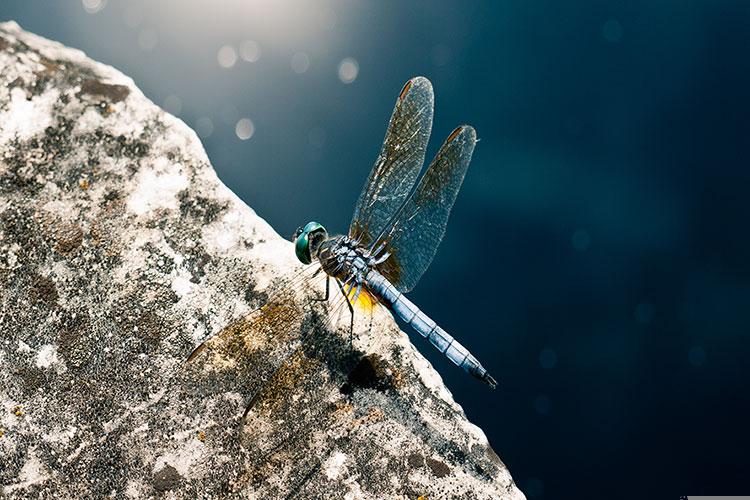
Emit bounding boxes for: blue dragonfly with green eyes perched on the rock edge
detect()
[188,77,497,389]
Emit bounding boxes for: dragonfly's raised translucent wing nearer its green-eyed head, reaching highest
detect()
[349,76,434,245]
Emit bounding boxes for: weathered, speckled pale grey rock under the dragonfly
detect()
[0,23,523,498]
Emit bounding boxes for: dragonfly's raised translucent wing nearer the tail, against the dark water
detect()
[373,125,476,292]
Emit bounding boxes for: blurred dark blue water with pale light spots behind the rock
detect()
[0,0,750,498]
